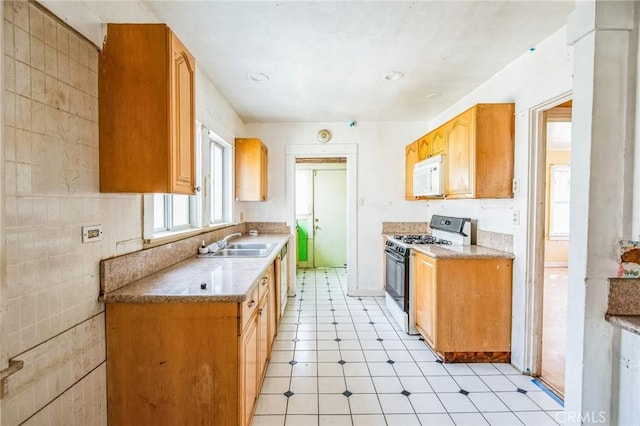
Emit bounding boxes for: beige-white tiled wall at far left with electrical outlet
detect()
[0,1,142,426]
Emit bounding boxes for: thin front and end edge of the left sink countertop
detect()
[98,234,291,304]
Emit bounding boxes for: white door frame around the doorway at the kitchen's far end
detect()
[285,144,358,296]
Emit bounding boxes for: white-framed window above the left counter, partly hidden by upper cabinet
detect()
[144,123,232,242]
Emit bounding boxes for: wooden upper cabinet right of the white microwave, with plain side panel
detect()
[445,104,514,198]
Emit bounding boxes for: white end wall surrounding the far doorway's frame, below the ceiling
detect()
[242,121,427,294]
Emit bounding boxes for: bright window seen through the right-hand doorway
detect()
[549,164,571,240]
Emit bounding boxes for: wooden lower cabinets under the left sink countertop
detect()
[106,265,276,426]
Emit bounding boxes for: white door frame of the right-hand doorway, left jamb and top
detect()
[524,91,573,376]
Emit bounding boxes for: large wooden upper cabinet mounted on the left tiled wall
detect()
[98,24,195,194]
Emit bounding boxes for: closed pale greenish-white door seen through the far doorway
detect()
[313,170,347,268]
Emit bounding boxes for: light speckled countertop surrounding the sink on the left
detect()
[102,234,292,303]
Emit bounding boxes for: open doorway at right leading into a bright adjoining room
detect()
[529,100,572,398]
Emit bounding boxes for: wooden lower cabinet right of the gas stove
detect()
[413,251,513,362]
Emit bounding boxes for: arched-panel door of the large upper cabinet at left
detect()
[170,33,195,194]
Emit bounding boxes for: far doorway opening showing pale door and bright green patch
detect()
[296,157,347,268]
